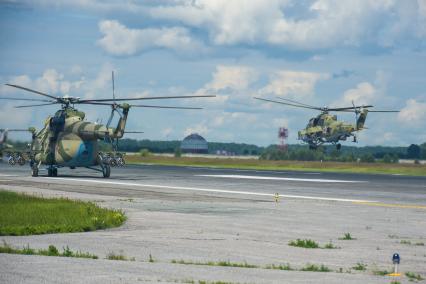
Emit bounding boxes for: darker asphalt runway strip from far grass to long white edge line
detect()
[0,163,426,206]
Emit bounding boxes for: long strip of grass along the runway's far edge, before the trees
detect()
[126,155,426,176]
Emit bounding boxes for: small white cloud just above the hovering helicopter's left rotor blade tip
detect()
[260,70,330,100]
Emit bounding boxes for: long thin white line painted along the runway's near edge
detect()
[40,177,377,203]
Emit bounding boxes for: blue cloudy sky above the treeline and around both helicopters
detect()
[0,0,426,146]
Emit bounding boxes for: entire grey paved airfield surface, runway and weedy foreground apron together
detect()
[0,163,426,283]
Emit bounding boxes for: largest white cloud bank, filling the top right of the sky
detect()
[150,0,426,50]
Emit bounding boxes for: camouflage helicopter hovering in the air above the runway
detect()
[254,97,399,150]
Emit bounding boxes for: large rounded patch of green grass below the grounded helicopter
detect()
[0,190,126,236]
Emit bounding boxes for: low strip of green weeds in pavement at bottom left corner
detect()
[0,241,98,259]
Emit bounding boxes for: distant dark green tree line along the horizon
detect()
[8,138,426,163]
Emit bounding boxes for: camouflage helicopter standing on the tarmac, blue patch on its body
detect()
[0,73,214,178]
